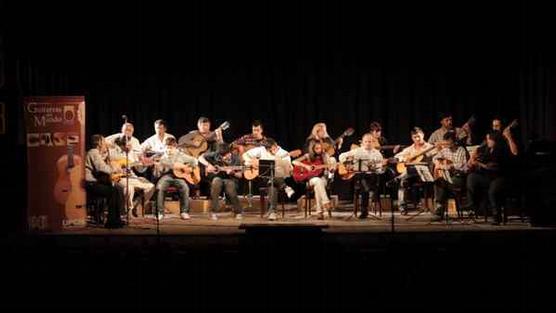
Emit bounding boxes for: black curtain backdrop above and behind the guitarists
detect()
[5,1,555,149]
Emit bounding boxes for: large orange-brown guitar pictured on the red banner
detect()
[54,145,82,205]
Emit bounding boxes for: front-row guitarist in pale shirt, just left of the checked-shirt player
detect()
[394,127,434,214]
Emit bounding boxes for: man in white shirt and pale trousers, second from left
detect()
[105,123,155,217]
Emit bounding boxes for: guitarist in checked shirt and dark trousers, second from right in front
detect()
[433,131,467,220]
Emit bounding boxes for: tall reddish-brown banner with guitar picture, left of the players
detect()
[23,96,87,231]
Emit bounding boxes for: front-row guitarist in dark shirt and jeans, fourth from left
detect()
[199,143,243,220]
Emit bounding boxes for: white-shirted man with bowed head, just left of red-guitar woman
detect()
[242,138,294,220]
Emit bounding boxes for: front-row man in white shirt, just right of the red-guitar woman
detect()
[339,133,386,219]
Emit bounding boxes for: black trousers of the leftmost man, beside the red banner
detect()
[85,182,124,227]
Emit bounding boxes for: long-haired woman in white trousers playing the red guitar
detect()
[292,142,336,220]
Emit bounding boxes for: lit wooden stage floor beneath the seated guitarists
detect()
[58,207,543,235]
